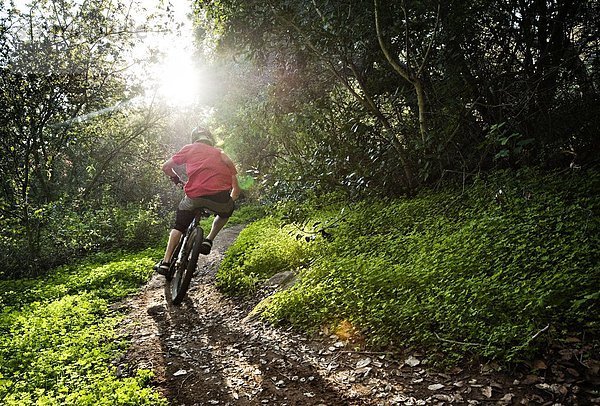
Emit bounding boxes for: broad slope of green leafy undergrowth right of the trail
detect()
[217,171,600,361]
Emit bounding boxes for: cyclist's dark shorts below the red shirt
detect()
[173,190,234,233]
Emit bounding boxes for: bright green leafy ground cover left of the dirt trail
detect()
[0,250,166,405]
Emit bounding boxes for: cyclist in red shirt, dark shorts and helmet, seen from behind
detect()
[154,127,241,275]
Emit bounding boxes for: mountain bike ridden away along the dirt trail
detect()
[166,209,211,305]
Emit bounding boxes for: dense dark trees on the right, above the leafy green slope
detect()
[195,0,600,196]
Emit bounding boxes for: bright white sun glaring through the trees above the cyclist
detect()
[157,48,201,106]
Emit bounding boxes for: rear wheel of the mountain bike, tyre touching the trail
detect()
[171,227,204,305]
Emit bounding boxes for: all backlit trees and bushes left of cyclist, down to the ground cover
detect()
[0,0,175,279]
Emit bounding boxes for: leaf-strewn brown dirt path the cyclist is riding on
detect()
[121,227,593,406]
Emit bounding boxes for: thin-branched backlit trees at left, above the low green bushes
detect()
[0,0,171,276]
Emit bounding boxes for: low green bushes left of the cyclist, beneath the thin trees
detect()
[0,199,172,279]
